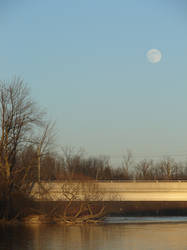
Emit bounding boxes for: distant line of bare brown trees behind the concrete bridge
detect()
[16,146,187,181]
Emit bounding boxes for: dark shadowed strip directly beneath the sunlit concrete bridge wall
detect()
[35,201,187,216]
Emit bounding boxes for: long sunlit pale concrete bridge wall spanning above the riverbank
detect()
[32,181,187,201]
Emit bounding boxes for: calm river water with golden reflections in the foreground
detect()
[0,217,187,250]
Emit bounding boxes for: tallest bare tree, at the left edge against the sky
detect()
[0,78,44,219]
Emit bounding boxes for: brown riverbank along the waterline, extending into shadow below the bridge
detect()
[0,201,187,224]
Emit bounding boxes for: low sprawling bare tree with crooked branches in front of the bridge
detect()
[33,180,105,223]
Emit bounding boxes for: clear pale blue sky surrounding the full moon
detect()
[0,0,187,165]
